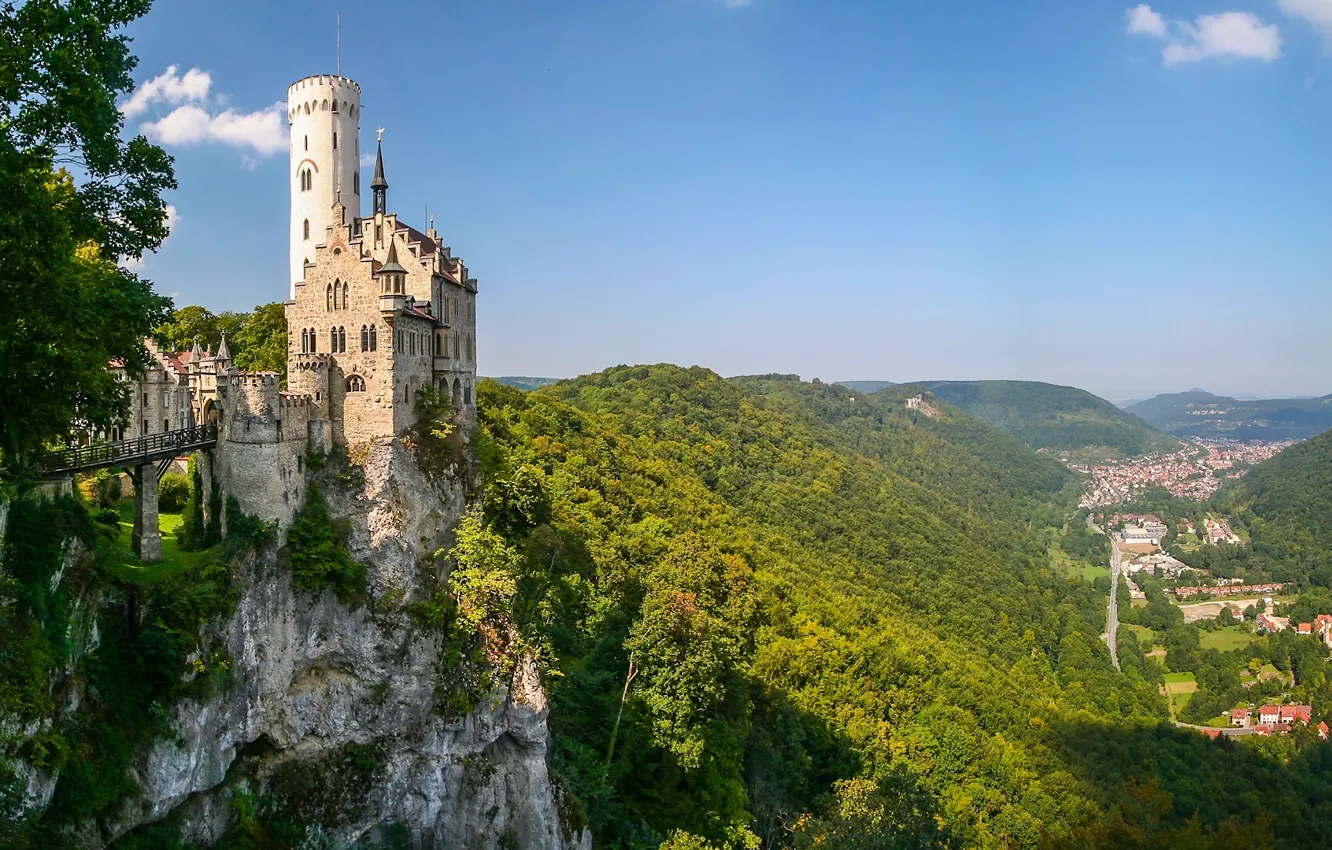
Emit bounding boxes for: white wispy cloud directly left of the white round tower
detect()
[120,65,288,163]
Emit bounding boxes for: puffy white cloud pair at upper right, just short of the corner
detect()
[1127,0,1278,68]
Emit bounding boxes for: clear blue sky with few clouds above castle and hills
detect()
[127,0,1332,400]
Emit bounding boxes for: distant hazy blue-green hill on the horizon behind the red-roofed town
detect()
[1126,390,1332,440]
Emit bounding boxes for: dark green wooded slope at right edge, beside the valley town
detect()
[1216,430,1332,588]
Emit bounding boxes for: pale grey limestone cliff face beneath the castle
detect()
[111,440,590,850]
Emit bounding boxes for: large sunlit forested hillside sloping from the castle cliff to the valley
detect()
[477,366,1332,849]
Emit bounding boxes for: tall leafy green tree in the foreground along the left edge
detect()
[0,0,176,481]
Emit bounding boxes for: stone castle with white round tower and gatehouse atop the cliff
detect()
[109,75,477,560]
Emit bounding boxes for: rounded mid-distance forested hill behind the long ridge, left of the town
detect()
[912,381,1175,457]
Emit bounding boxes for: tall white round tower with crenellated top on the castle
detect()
[286,75,361,297]
